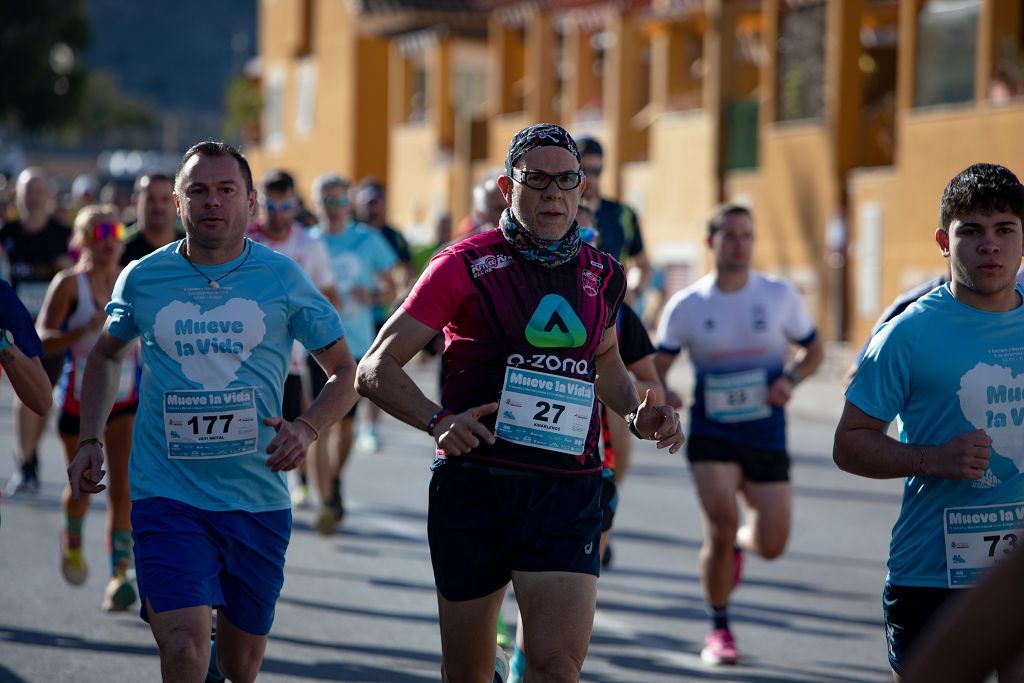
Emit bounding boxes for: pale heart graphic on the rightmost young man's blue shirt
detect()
[957,362,1024,471]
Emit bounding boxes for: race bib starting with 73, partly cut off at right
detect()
[942,503,1024,588]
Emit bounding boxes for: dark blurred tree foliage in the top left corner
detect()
[0,0,90,130]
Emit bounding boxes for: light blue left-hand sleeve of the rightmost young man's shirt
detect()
[846,323,913,422]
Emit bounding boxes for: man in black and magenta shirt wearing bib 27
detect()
[356,124,683,681]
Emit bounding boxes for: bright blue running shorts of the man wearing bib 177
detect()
[131,498,292,636]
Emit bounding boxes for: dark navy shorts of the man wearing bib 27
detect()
[427,463,602,601]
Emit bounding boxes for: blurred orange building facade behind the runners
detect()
[247,0,1024,342]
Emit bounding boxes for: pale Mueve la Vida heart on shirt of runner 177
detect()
[154,297,266,389]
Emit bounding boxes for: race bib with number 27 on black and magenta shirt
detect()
[495,368,595,456]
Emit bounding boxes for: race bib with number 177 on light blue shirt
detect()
[164,387,259,460]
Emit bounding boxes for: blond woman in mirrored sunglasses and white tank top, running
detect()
[39,204,138,611]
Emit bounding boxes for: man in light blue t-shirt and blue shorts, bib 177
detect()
[69,142,355,681]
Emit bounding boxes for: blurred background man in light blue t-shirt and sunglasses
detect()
[310,173,398,536]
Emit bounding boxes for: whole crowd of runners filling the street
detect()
[0,124,1024,683]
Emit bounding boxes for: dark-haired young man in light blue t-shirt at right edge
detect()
[835,164,1024,681]
